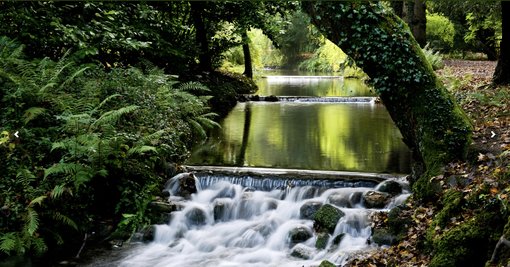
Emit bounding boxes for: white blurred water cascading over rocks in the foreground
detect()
[106,175,405,267]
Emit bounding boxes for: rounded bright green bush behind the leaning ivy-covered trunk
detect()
[427,14,455,53]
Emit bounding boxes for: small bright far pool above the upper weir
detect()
[255,76,374,96]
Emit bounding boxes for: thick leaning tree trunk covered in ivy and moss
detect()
[302,1,472,198]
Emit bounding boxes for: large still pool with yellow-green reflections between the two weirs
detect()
[188,102,409,173]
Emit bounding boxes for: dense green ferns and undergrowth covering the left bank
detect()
[0,38,217,257]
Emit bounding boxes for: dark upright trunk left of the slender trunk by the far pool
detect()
[190,1,212,71]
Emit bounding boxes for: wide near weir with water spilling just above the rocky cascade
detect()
[185,166,405,191]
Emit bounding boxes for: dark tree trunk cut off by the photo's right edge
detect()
[492,1,510,85]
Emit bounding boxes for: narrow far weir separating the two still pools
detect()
[238,95,380,104]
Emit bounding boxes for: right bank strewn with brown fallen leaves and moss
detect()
[348,60,510,266]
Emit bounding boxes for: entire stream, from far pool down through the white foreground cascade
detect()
[83,76,410,267]
